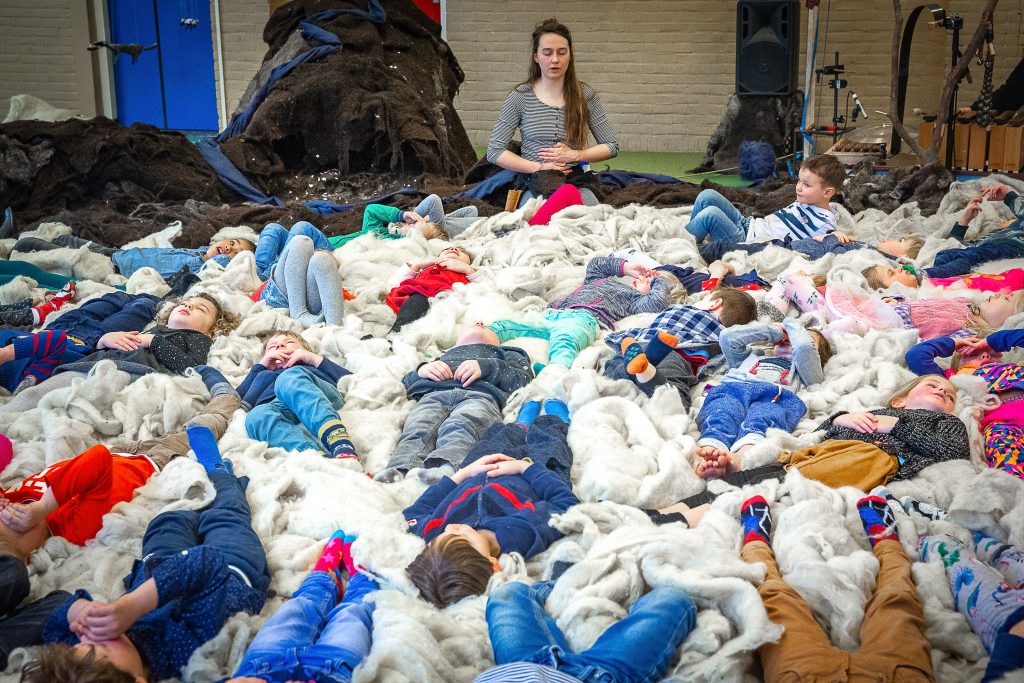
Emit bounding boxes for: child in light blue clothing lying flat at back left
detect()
[14,227,258,278]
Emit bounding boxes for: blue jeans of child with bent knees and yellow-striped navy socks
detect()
[246,366,344,451]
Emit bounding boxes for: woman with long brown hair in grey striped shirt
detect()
[487,18,618,202]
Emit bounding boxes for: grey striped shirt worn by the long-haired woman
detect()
[487,83,618,164]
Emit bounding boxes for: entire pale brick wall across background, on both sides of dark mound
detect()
[0,0,1022,151]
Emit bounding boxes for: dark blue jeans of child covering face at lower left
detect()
[136,471,270,593]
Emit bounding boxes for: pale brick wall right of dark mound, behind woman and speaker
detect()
[447,0,1021,151]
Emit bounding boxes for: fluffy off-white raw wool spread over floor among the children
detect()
[0,179,1024,682]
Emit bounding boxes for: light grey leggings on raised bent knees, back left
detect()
[270,234,345,328]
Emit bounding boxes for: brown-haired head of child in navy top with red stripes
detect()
[406,524,501,608]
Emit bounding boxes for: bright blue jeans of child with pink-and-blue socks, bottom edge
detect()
[234,571,378,681]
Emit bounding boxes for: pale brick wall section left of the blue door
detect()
[0,0,96,120]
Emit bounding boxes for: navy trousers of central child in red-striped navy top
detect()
[460,415,572,486]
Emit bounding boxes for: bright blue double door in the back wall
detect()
[108,0,218,131]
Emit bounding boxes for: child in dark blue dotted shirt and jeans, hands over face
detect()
[7,432,270,683]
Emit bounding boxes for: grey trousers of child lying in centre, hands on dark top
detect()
[387,389,502,472]
